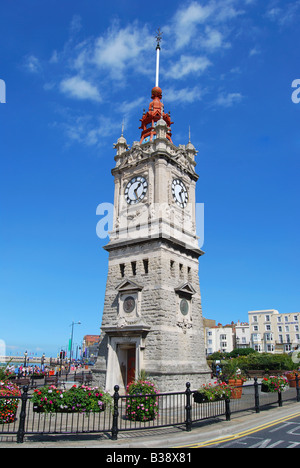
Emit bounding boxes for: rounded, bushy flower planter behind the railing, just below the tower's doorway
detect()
[126,380,158,422]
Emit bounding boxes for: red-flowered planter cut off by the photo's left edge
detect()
[0,381,21,424]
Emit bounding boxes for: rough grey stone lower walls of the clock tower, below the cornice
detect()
[92,241,208,391]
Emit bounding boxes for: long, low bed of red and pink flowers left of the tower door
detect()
[32,385,112,413]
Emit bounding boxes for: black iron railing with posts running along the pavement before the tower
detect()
[0,375,300,444]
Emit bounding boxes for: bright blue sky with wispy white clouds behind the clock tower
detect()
[0,0,300,355]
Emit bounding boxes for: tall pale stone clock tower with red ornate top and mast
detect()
[93,38,210,392]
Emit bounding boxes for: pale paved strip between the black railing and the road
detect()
[0,403,300,451]
